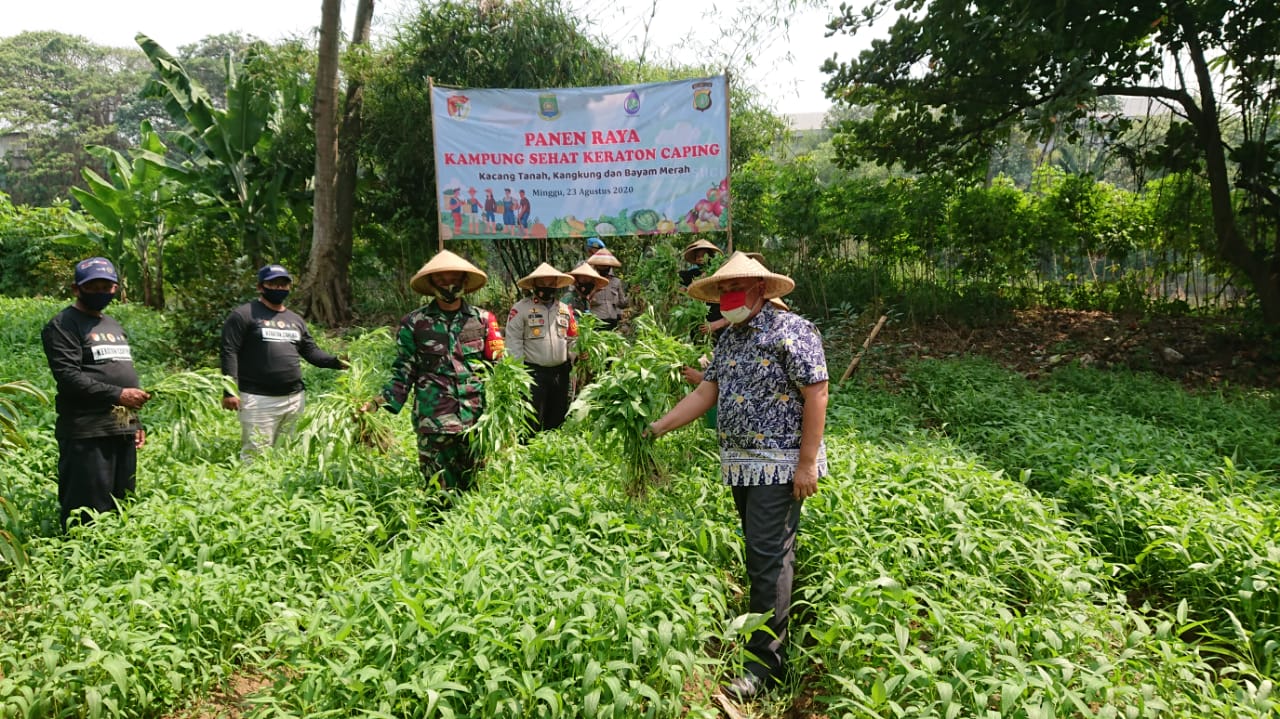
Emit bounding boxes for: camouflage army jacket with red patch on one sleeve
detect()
[383,301,503,435]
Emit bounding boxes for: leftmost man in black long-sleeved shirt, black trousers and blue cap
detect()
[40,257,151,528]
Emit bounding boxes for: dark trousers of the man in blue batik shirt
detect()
[732,484,804,681]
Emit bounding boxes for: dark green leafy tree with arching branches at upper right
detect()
[824,0,1280,322]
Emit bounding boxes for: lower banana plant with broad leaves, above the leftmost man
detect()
[72,122,191,308]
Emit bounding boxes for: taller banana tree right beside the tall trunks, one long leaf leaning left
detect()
[136,33,310,265]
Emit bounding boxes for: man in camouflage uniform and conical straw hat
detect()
[366,249,503,490]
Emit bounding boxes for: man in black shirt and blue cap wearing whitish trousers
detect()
[221,265,347,462]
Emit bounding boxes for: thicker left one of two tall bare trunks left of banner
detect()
[301,0,351,325]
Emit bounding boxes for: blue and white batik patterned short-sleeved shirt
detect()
[704,303,827,486]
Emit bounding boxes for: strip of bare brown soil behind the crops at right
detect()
[832,310,1280,389]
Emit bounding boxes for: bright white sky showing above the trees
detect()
[0,0,854,113]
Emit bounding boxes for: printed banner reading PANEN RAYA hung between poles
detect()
[431,77,728,239]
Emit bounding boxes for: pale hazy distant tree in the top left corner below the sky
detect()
[0,32,147,206]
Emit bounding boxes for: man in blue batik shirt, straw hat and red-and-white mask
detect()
[646,252,827,701]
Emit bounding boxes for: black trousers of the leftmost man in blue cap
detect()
[58,434,138,528]
